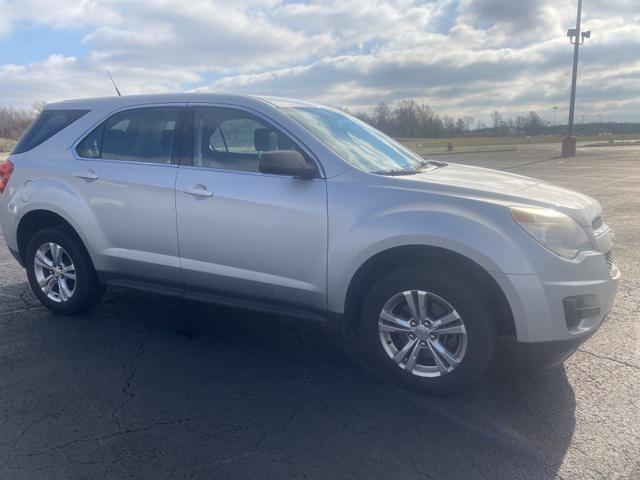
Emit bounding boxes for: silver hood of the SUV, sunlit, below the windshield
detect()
[394,163,601,226]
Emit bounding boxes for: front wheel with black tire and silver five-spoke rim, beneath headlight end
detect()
[358,265,496,395]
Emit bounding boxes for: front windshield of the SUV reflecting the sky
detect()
[282,107,424,173]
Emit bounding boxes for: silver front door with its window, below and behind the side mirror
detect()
[176,106,327,310]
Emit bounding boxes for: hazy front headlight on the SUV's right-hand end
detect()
[509,207,591,258]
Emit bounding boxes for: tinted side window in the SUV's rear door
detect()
[76,107,180,164]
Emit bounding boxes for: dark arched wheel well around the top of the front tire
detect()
[344,245,516,336]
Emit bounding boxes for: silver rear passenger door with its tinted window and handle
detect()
[74,104,185,291]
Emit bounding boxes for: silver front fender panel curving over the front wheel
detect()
[327,182,555,313]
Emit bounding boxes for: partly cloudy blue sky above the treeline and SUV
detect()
[0,0,640,123]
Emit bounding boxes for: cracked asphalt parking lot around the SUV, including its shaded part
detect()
[0,145,640,479]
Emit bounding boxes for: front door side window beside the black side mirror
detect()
[193,107,301,172]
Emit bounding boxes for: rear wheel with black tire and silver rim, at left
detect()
[25,226,104,315]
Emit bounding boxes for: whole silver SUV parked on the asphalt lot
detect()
[0,94,620,393]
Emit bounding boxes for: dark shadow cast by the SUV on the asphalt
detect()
[0,284,575,479]
